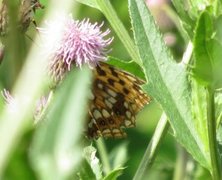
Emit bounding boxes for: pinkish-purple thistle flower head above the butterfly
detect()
[39,15,113,81]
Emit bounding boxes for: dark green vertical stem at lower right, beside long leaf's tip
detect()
[207,87,221,180]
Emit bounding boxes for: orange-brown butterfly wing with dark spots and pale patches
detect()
[88,63,150,138]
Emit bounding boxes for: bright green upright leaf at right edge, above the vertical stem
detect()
[192,11,222,88]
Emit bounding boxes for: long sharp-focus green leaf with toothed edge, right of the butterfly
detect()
[129,0,210,169]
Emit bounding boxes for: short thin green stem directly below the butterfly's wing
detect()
[96,138,111,175]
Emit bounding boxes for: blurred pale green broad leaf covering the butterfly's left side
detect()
[31,67,90,179]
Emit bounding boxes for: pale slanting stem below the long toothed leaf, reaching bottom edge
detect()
[133,113,169,180]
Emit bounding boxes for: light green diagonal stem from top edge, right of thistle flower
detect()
[96,0,142,65]
